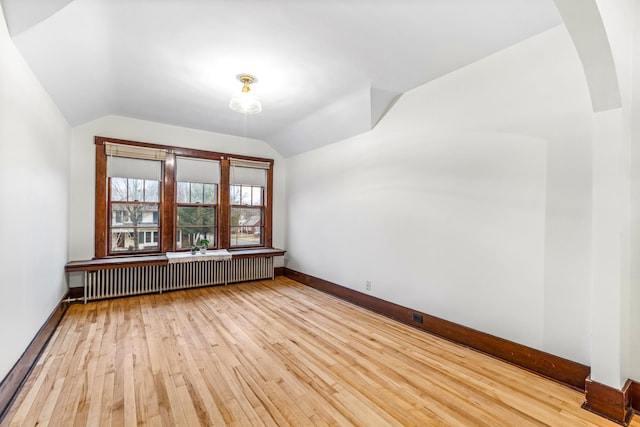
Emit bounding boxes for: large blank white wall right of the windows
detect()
[286,27,593,364]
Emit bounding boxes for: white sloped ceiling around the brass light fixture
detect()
[0,0,561,156]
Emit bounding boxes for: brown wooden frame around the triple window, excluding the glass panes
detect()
[94,136,274,258]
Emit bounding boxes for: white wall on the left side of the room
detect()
[0,4,71,379]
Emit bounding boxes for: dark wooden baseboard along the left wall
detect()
[0,295,68,422]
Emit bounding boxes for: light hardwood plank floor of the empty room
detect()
[2,278,640,427]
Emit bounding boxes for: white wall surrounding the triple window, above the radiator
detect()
[69,116,285,266]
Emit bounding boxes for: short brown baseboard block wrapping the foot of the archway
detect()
[582,378,633,426]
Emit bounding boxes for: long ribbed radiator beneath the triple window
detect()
[84,257,274,302]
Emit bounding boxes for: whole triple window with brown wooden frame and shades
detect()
[95,137,273,258]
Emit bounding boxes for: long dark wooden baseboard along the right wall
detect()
[284,267,590,391]
